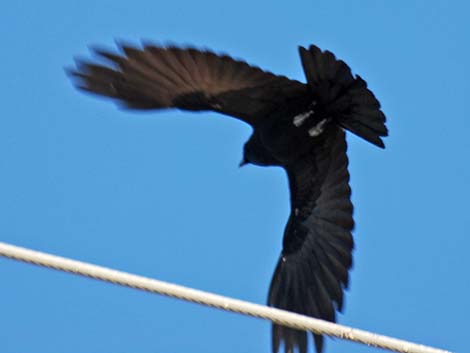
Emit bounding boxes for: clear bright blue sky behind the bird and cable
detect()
[0,0,470,353]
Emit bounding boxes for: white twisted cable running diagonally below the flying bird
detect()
[0,242,450,353]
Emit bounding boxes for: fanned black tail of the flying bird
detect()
[299,45,388,148]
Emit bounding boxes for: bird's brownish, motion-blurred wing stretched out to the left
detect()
[68,45,308,125]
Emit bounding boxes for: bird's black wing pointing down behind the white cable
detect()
[268,127,354,353]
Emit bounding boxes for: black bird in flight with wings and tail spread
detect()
[68,44,387,353]
